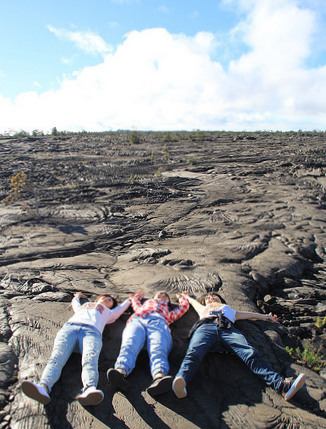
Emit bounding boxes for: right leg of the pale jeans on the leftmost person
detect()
[79,326,102,390]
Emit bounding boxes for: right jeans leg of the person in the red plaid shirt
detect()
[146,315,172,378]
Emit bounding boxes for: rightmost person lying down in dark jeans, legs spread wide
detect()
[172,293,306,400]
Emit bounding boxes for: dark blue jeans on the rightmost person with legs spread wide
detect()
[176,323,284,392]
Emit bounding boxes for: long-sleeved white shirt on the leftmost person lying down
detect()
[68,297,130,334]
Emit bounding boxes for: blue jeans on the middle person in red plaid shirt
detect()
[115,314,172,378]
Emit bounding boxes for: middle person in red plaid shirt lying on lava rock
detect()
[108,291,189,396]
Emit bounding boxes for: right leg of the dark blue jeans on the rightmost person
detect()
[220,328,284,391]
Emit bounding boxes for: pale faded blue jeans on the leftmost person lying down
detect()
[40,322,102,391]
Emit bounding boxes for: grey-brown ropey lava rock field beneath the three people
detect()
[0,132,326,429]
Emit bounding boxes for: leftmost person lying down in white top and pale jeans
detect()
[22,292,130,405]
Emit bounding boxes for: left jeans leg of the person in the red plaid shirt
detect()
[114,316,146,375]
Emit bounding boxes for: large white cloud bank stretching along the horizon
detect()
[0,0,326,132]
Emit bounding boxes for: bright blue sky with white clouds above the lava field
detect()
[0,0,326,133]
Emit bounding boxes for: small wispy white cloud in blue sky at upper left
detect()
[48,25,112,54]
